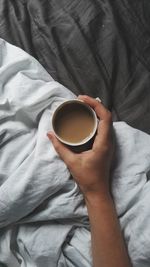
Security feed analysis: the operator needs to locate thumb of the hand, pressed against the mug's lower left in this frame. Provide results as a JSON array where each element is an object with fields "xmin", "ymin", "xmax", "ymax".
[{"xmin": 47, "ymin": 132, "xmax": 75, "ymax": 167}]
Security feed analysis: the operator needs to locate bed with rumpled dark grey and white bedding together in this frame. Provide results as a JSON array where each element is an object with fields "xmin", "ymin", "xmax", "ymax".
[{"xmin": 0, "ymin": 0, "xmax": 150, "ymax": 267}]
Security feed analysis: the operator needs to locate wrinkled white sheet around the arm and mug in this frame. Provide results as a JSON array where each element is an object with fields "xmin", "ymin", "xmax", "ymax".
[{"xmin": 0, "ymin": 39, "xmax": 150, "ymax": 267}]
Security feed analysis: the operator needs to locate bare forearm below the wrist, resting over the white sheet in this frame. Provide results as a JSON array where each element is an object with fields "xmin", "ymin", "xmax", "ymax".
[{"xmin": 85, "ymin": 195, "xmax": 131, "ymax": 267}]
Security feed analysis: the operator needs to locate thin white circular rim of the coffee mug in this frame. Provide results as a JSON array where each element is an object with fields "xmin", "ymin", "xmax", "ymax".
[{"xmin": 52, "ymin": 99, "xmax": 98, "ymax": 147}]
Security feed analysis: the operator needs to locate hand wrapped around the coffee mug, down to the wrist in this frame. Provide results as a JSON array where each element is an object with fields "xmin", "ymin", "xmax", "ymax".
[{"xmin": 47, "ymin": 95, "xmax": 113, "ymax": 201}]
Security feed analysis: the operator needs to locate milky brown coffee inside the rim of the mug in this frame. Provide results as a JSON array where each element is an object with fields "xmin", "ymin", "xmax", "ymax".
[{"xmin": 54, "ymin": 103, "xmax": 94, "ymax": 143}]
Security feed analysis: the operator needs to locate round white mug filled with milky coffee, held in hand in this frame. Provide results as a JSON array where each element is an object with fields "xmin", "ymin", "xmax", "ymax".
[{"xmin": 52, "ymin": 99, "xmax": 97, "ymax": 152}]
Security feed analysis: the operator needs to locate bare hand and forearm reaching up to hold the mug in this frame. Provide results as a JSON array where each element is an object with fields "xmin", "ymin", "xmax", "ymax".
[{"xmin": 48, "ymin": 96, "xmax": 131, "ymax": 267}]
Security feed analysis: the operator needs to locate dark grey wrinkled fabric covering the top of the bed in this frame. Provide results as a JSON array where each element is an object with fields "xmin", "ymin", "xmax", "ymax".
[{"xmin": 0, "ymin": 0, "xmax": 150, "ymax": 133}]
